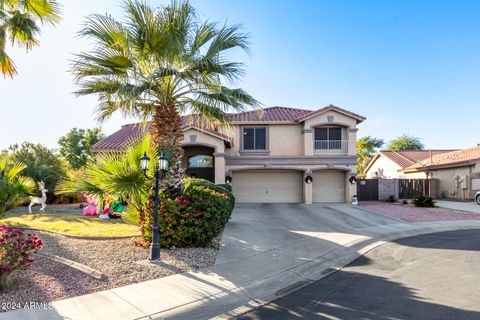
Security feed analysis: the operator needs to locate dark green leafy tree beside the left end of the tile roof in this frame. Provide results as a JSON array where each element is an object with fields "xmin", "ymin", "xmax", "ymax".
[{"xmin": 58, "ymin": 128, "xmax": 105, "ymax": 169}]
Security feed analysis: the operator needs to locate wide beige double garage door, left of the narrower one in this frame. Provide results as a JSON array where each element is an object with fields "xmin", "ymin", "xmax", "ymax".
[{"xmin": 232, "ymin": 170, "xmax": 303, "ymax": 203}]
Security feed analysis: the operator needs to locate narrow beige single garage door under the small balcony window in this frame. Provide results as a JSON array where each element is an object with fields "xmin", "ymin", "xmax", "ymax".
[{"xmin": 312, "ymin": 170, "xmax": 345, "ymax": 202}]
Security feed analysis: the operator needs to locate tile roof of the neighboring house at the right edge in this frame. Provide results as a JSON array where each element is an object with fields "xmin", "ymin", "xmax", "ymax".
[{"xmin": 405, "ymin": 146, "xmax": 480, "ymax": 171}]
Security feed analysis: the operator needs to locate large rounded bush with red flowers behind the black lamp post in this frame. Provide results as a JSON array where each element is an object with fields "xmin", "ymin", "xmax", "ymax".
[{"xmin": 142, "ymin": 185, "xmax": 231, "ymax": 247}]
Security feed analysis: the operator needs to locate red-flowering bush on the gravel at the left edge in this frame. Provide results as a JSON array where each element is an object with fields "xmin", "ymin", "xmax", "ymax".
[{"xmin": 0, "ymin": 226, "xmax": 42, "ymax": 289}]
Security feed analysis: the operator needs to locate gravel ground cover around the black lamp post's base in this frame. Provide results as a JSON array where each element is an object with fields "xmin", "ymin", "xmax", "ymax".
[{"xmin": 0, "ymin": 232, "xmax": 217, "ymax": 312}]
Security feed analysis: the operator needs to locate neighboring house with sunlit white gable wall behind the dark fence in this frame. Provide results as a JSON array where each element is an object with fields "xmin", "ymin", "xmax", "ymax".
[{"xmin": 365, "ymin": 150, "xmax": 454, "ymax": 179}]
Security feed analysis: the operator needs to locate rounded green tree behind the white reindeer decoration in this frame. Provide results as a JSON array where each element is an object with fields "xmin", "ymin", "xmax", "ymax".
[{"xmin": 9, "ymin": 142, "xmax": 66, "ymax": 202}]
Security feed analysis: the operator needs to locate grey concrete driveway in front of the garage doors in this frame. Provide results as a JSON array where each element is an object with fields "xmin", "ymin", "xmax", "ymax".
[{"xmin": 216, "ymin": 203, "xmax": 404, "ymax": 264}]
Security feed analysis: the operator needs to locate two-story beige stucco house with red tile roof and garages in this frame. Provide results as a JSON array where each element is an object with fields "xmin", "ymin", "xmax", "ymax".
[{"xmin": 92, "ymin": 105, "xmax": 365, "ymax": 203}]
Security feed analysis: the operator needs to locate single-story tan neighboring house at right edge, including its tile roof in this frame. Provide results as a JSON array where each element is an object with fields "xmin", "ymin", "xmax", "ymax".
[{"xmin": 403, "ymin": 146, "xmax": 480, "ymax": 199}]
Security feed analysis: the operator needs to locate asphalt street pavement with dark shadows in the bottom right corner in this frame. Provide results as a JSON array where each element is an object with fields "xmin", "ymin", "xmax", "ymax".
[{"xmin": 238, "ymin": 230, "xmax": 480, "ymax": 320}]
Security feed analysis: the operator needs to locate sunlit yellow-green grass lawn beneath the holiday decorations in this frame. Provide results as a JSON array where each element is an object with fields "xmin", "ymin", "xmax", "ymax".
[{"xmin": 0, "ymin": 211, "xmax": 140, "ymax": 237}]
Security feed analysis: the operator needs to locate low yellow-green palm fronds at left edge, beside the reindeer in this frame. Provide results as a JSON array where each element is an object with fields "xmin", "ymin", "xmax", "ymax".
[{"xmin": 0, "ymin": 154, "xmax": 35, "ymax": 217}]
